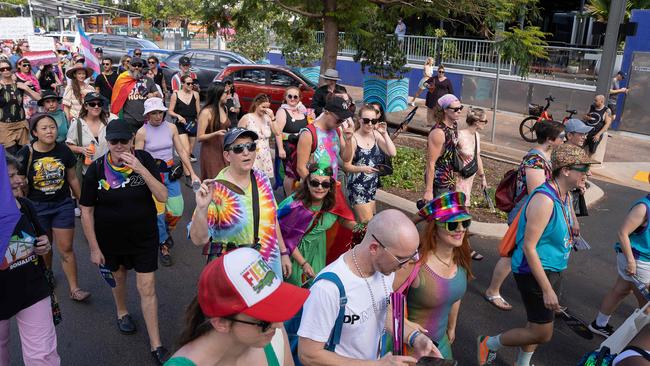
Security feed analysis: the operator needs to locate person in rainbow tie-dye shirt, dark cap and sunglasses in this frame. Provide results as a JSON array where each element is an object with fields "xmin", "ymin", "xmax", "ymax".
[{"xmin": 189, "ymin": 127, "xmax": 291, "ymax": 277}]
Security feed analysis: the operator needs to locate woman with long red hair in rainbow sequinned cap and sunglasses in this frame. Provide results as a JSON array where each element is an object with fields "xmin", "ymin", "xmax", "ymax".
[{"xmin": 394, "ymin": 192, "xmax": 472, "ymax": 359}]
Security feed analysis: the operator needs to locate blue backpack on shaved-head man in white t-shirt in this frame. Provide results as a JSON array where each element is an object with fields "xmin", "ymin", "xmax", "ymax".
[{"xmin": 284, "ymin": 272, "xmax": 348, "ymax": 366}]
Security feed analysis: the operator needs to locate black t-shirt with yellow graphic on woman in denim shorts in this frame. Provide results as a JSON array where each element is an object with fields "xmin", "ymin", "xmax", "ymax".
[{"xmin": 17, "ymin": 142, "xmax": 77, "ymax": 202}]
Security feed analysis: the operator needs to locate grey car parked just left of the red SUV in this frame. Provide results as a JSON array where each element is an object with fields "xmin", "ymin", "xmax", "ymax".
[{"xmin": 160, "ymin": 48, "xmax": 254, "ymax": 91}]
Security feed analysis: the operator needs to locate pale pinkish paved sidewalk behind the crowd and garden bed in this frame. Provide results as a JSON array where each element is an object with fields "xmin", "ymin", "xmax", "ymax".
[{"xmin": 346, "ymin": 86, "xmax": 650, "ymax": 191}]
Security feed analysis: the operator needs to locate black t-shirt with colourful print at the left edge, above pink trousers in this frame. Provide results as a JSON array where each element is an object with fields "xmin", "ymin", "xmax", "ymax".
[{"xmin": 0, "ymin": 198, "xmax": 50, "ymax": 320}]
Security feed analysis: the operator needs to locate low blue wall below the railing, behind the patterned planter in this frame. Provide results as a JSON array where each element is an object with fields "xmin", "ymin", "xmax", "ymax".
[{"xmin": 268, "ymin": 52, "xmax": 463, "ymax": 100}]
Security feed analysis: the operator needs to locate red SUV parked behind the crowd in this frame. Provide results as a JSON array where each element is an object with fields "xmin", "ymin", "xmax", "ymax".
[{"xmin": 214, "ymin": 64, "xmax": 318, "ymax": 113}]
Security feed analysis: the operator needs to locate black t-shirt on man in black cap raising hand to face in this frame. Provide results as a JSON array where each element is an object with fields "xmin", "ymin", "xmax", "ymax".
[{"xmin": 79, "ymin": 150, "xmax": 162, "ymax": 255}]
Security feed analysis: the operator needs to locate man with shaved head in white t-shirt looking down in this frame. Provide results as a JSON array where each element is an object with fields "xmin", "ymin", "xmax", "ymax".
[{"xmin": 298, "ymin": 210, "xmax": 440, "ymax": 365}]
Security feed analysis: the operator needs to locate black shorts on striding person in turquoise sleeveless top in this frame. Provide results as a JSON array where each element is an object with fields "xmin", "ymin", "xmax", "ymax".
[{"xmin": 513, "ymin": 271, "xmax": 562, "ymax": 324}]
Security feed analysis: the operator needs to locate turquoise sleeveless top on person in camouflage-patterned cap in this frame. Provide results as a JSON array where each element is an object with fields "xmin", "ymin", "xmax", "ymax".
[{"xmin": 512, "ymin": 181, "xmax": 573, "ymax": 274}]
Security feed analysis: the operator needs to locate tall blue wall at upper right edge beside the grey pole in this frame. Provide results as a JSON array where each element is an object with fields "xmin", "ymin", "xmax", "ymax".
[{"xmin": 613, "ymin": 9, "xmax": 650, "ymax": 128}]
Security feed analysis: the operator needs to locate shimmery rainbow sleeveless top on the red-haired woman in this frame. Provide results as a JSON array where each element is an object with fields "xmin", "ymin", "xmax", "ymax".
[{"xmin": 406, "ymin": 264, "xmax": 467, "ymax": 359}]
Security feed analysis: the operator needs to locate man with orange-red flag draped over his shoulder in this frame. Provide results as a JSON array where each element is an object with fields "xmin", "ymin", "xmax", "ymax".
[{"xmin": 111, "ymin": 57, "xmax": 162, "ymax": 130}]
